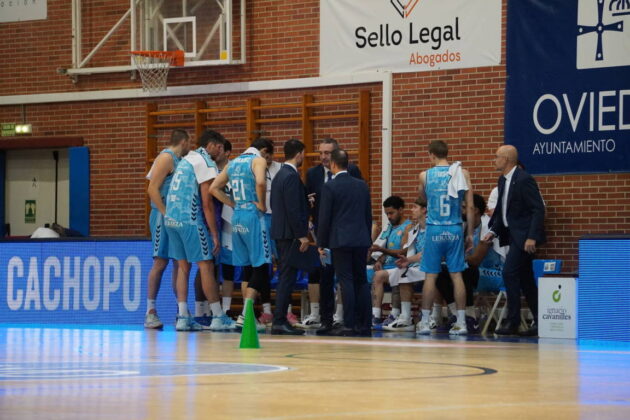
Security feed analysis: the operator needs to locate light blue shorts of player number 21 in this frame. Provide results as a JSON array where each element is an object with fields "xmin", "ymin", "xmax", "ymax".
[{"xmin": 232, "ymin": 208, "xmax": 271, "ymax": 267}]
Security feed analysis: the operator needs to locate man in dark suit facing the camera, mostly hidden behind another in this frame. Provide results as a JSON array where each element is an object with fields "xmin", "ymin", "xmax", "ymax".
[{"xmin": 306, "ymin": 138, "xmax": 363, "ymax": 334}]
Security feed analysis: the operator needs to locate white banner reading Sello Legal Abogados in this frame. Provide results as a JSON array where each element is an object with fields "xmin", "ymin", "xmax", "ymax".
[{"xmin": 320, "ymin": 0, "xmax": 501, "ymax": 75}]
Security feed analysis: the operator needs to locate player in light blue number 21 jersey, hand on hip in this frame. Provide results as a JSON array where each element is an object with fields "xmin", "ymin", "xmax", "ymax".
[{"xmin": 210, "ymin": 138, "xmax": 273, "ymax": 332}]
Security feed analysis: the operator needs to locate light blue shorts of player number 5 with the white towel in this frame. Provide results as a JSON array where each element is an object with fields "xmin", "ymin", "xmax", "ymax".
[{"xmin": 165, "ymin": 220, "xmax": 214, "ymax": 263}]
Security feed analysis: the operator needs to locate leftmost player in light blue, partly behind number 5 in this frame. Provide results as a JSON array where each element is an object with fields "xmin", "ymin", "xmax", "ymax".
[{"xmin": 144, "ymin": 129, "xmax": 190, "ymax": 328}]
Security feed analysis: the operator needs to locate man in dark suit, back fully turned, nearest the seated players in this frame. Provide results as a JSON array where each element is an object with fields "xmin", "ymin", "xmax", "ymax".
[{"xmin": 317, "ymin": 149, "xmax": 372, "ymax": 336}]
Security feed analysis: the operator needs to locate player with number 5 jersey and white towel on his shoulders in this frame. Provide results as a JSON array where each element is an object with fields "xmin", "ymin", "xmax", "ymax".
[{"xmin": 164, "ymin": 141, "xmax": 234, "ymax": 331}]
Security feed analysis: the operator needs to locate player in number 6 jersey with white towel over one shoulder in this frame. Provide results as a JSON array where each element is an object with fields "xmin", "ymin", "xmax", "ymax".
[{"xmin": 417, "ymin": 140, "xmax": 474, "ymax": 335}]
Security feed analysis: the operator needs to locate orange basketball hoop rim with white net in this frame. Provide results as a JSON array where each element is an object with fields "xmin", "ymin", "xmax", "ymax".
[{"xmin": 131, "ymin": 51, "xmax": 184, "ymax": 92}]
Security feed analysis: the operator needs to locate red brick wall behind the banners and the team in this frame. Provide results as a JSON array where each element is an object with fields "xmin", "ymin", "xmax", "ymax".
[{"xmin": 0, "ymin": 0, "xmax": 630, "ymax": 270}]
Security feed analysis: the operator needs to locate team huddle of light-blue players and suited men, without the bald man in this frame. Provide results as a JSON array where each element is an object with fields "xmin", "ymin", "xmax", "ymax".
[{"xmin": 145, "ymin": 130, "xmax": 524, "ymax": 335}]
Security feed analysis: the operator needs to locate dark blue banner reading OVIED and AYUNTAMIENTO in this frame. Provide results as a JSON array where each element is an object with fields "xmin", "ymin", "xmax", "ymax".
[{"xmin": 505, "ymin": 0, "xmax": 630, "ymax": 174}]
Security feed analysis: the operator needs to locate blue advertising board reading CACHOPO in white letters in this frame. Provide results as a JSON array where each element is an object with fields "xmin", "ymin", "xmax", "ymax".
[{"xmin": 0, "ymin": 240, "xmax": 177, "ymax": 325}]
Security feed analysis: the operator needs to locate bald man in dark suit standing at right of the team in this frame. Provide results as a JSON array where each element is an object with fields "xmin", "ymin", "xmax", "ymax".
[{"xmin": 484, "ymin": 145, "xmax": 546, "ymax": 335}]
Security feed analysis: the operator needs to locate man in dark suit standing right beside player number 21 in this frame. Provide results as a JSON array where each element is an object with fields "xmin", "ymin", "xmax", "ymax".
[{"xmin": 271, "ymin": 139, "xmax": 308, "ymax": 335}]
